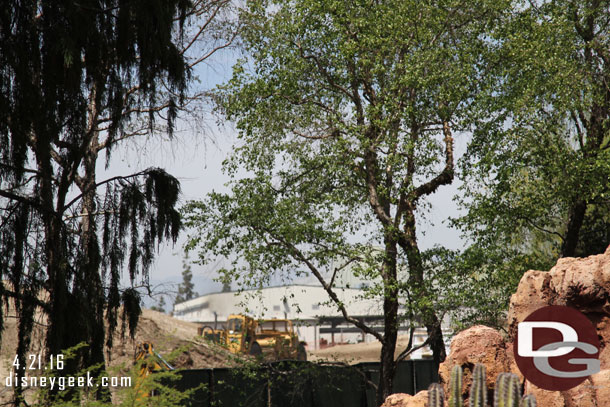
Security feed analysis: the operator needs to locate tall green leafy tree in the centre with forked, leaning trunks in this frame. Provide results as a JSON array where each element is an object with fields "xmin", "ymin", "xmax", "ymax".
[{"xmin": 185, "ymin": 0, "xmax": 502, "ymax": 404}]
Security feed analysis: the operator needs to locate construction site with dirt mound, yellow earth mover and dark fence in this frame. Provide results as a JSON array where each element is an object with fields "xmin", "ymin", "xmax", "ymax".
[{"xmin": 0, "ymin": 309, "xmax": 437, "ymax": 407}]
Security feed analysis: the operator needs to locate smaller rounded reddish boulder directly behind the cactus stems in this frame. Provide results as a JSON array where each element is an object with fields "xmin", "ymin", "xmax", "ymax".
[{"xmin": 439, "ymin": 325, "xmax": 518, "ymax": 397}]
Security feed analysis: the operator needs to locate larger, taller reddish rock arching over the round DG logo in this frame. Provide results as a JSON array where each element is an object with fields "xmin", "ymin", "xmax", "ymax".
[{"xmin": 508, "ymin": 247, "xmax": 610, "ymax": 369}]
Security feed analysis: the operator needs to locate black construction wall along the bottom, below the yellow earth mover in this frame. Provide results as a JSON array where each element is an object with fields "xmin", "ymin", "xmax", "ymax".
[{"xmin": 172, "ymin": 360, "xmax": 438, "ymax": 407}]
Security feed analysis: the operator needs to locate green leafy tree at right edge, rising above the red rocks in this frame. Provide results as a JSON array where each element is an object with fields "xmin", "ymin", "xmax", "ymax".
[{"xmin": 459, "ymin": 0, "xmax": 610, "ymax": 316}]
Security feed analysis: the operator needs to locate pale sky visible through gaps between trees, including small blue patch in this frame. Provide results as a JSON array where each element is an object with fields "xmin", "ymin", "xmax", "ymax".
[{"xmin": 98, "ymin": 42, "xmax": 467, "ymax": 310}]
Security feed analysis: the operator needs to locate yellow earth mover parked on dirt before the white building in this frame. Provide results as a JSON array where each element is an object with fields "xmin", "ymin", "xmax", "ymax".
[{"xmin": 200, "ymin": 315, "xmax": 307, "ymax": 360}]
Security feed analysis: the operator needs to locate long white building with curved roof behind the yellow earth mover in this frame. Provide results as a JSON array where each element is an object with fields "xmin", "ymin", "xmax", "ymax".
[{"xmin": 173, "ymin": 285, "xmax": 446, "ymax": 358}]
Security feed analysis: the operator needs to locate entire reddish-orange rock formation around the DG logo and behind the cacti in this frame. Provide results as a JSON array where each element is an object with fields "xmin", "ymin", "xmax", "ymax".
[{"xmin": 384, "ymin": 247, "xmax": 610, "ymax": 407}]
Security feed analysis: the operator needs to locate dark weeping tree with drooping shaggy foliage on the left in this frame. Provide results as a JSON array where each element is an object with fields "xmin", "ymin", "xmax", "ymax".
[{"xmin": 0, "ymin": 0, "xmax": 233, "ymax": 402}]
